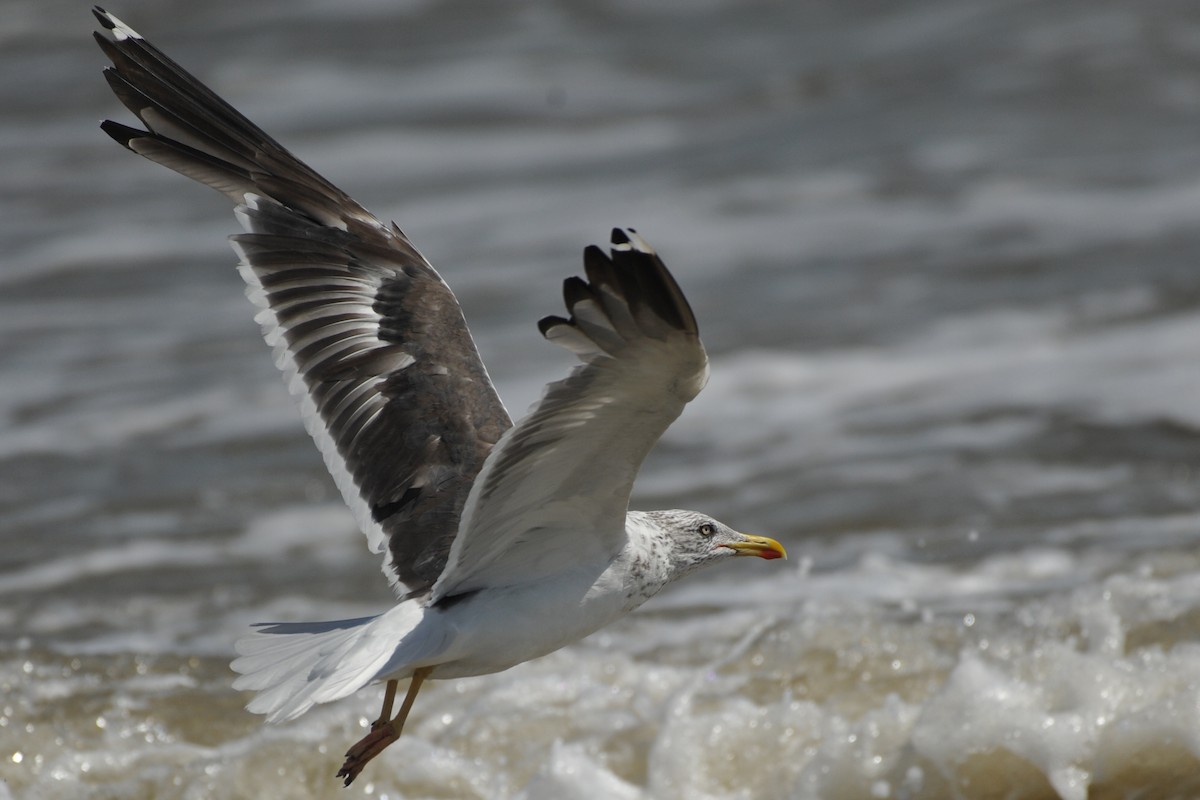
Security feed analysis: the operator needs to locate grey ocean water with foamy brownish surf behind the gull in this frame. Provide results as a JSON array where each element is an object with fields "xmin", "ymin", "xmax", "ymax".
[{"xmin": 7, "ymin": 0, "xmax": 1200, "ymax": 800}]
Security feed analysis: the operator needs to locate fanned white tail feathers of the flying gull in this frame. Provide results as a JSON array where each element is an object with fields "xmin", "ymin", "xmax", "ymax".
[{"xmin": 230, "ymin": 603, "xmax": 421, "ymax": 722}]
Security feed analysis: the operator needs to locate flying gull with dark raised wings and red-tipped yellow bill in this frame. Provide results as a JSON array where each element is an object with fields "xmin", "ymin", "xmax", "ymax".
[{"xmin": 94, "ymin": 7, "xmax": 787, "ymax": 786}]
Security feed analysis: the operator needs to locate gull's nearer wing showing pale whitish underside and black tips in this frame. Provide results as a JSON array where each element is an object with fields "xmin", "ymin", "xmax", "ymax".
[{"xmin": 432, "ymin": 229, "xmax": 708, "ymax": 602}]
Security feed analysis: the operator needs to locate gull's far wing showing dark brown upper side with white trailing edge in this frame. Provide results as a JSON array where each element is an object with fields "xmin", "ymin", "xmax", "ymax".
[{"xmin": 95, "ymin": 8, "xmax": 511, "ymax": 593}]
